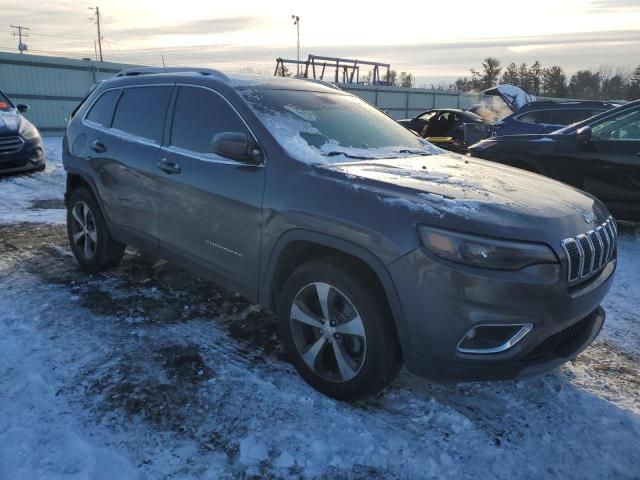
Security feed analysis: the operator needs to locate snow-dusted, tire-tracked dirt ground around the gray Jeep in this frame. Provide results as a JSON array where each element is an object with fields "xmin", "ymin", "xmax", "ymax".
[{"xmin": 0, "ymin": 139, "xmax": 640, "ymax": 480}]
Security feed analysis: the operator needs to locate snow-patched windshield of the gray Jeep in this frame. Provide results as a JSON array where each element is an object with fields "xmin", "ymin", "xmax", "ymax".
[{"xmin": 241, "ymin": 88, "xmax": 442, "ymax": 163}]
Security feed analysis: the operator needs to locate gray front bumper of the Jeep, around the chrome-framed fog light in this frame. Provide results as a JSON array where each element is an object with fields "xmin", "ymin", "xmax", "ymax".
[{"xmin": 389, "ymin": 248, "xmax": 616, "ymax": 382}]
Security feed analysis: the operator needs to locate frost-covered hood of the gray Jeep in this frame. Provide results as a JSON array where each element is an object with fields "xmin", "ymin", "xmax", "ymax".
[{"xmin": 320, "ymin": 154, "xmax": 608, "ymax": 242}]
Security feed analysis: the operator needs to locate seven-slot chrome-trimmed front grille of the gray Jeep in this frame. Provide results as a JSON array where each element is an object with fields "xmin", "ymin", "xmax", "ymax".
[{"xmin": 562, "ymin": 217, "xmax": 618, "ymax": 282}]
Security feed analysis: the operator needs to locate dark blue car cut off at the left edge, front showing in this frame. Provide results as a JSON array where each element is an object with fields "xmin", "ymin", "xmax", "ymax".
[{"xmin": 0, "ymin": 91, "xmax": 45, "ymax": 175}]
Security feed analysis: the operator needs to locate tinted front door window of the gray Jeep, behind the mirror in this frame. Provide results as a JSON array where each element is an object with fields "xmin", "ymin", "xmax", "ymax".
[{"xmin": 171, "ymin": 87, "xmax": 249, "ymax": 154}]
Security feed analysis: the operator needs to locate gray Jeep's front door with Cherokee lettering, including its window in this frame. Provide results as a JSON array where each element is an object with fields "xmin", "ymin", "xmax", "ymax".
[{"xmin": 156, "ymin": 85, "xmax": 265, "ymax": 289}]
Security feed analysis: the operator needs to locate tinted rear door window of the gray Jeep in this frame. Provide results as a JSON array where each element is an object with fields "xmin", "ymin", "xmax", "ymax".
[{"xmin": 113, "ymin": 86, "xmax": 171, "ymax": 144}]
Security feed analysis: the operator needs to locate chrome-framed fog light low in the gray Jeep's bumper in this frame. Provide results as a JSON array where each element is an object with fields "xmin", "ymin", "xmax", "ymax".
[{"xmin": 458, "ymin": 323, "xmax": 533, "ymax": 354}]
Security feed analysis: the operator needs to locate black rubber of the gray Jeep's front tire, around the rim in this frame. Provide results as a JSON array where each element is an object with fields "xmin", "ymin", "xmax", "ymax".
[{"xmin": 278, "ymin": 257, "xmax": 402, "ymax": 400}]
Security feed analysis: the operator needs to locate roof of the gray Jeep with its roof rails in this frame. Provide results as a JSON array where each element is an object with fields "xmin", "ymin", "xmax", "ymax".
[{"xmin": 104, "ymin": 67, "xmax": 342, "ymax": 93}]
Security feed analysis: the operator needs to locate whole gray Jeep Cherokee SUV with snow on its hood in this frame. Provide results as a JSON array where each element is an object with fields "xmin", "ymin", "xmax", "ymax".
[{"xmin": 63, "ymin": 69, "xmax": 617, "ymax": 400}]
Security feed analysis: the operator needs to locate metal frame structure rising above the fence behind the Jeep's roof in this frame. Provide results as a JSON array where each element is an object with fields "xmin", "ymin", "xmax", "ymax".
[{"xmin": 273, "ymin": 54, "xmax": 391, "ymax": 85}]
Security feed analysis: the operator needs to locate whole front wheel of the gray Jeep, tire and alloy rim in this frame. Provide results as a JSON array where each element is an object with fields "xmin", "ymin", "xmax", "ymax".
[{"xmin": 278, "ymin": 258, "xmax": 402, "ymax": 400}]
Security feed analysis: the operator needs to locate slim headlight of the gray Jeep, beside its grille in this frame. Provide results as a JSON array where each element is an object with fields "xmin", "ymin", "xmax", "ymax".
[{"xmin": 418, "ymin": 226, "xmax": 558, "ymax": 270}]
